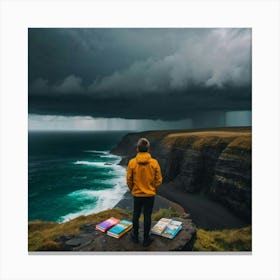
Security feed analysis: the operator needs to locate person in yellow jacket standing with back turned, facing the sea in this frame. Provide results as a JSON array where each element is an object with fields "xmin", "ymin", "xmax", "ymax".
[{"xmin": 126, "ymin": 138, "xmax": 162, "ymax": 247}]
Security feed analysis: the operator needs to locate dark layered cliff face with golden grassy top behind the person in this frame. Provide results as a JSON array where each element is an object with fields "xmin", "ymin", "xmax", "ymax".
[{"xmin": 112, "ymin": 128, "xmax": 251, "ymax": 221}]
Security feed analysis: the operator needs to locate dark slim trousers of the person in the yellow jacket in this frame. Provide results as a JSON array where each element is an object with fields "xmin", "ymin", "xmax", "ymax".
[{"xmin": 132, "ymin": 196, "xmax": 155, "ymax": 239}]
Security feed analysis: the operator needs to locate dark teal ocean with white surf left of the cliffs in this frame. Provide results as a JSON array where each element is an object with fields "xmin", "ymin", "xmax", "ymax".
[{"xmin": 28, "ymin": 131, "xmax": 127, "ymax": 223}]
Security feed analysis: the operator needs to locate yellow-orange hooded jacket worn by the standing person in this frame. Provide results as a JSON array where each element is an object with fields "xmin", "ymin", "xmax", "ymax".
[{"xmin": 126, "ymin": 152, "xmax": 162, "ymax": 196}]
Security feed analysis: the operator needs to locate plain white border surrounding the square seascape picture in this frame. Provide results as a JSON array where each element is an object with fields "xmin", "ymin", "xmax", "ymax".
[{"xmin": 0, "ymin": 0, "xmax": 280, "ymax": 279}]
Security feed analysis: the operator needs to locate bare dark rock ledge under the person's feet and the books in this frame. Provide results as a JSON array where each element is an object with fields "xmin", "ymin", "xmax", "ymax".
[{"xmin": 49, "ymin": 218, "xmax": 196, "ymax": 252}]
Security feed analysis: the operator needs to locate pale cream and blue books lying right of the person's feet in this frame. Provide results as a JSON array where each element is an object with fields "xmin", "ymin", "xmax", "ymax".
[{"xmin": 151, "ymin": 218, "xmax": 182, "ymax": 239}]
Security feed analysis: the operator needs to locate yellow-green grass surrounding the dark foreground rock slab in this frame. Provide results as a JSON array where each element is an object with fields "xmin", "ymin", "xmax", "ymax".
[{"xmin": 28, "ymin": 208, "xmax": 252, "ymax": 251}]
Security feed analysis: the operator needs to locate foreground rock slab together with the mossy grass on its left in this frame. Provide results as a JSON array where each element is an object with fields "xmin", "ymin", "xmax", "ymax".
[{"xmin": 28, "ymin": 208, "xmax": 197, "ymax": 252}]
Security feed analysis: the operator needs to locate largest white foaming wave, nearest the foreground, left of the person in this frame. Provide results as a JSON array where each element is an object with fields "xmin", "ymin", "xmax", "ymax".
[{"xmin": 58, "ymin": 178, "xmax": 127, "ymax": 223}]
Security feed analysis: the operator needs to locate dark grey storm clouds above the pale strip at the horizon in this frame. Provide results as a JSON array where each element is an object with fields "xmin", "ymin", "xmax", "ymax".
[{"xmin": 28, "ymin": 28, "xmax": 252, "ymax": 126}]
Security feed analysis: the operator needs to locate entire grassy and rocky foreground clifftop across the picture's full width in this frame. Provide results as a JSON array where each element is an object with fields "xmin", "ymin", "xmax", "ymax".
[{"xmin": 28, "ymin": 208, "xmax": 252, "ymax": 253}]
